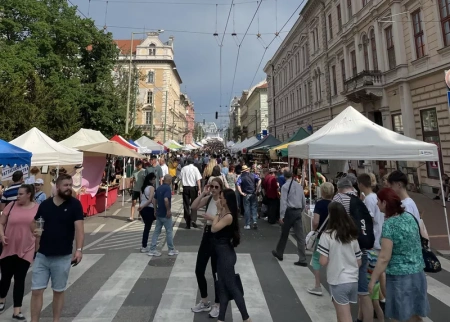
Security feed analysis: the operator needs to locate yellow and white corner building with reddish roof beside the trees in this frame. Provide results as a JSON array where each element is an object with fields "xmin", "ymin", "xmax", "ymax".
[{"xmin": 115, "ymin": 32, "xmax": 195, "ymax": 143}]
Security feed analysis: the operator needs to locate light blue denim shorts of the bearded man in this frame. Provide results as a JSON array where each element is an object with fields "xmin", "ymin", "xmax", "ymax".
[{"xmin": 31, "ymin": 253, "xmax": 72, "ymax": 292}]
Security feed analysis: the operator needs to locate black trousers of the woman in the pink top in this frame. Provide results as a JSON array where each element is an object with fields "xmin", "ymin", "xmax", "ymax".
[{"xmin": 0, "ymin": 255, "xmax": 30, "ymax": 307}]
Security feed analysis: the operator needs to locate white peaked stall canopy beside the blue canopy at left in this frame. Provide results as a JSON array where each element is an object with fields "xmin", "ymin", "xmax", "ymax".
[{"xmin": 9, "ymin": 127, "xmax": 83, "ymax": 167}]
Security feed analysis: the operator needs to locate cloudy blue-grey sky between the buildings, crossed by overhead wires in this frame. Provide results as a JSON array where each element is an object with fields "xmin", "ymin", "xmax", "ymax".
[{"xmin": 70, "ymin": 0, "xmax": 303, "ymax": 126}]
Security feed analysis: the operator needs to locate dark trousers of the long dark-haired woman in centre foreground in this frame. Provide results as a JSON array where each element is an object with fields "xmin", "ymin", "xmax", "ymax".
[{"xmin": 215, "ymin": 240, "xmax": 249, "ymax": 321}]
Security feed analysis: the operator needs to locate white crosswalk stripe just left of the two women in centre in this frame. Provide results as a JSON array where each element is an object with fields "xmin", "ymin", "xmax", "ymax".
[{"xmin": 153, "ymin": 253, "xmax": 198, "ymax": 322}]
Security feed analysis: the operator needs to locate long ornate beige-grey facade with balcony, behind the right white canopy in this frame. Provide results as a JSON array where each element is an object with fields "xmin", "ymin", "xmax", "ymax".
[{"xmin": 264, "ymin": 0, "xmax": 450, "ymax": 186}]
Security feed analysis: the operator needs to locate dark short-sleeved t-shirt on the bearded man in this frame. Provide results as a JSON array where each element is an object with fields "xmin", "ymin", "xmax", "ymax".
[{"xmin": 34, "ymin": 197, "xmax": 84, "ymax": 256}]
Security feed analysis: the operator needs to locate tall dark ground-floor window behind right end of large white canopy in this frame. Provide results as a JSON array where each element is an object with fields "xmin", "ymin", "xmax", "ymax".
[{"xmin": 420, "ymin": 108, "xmax": 442, "ymax": 179}]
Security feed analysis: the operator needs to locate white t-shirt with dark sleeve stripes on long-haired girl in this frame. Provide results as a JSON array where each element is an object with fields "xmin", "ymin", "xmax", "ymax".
[{"xmin": 317, "ymin": 232, "xmax": 361, "ymax": 285}]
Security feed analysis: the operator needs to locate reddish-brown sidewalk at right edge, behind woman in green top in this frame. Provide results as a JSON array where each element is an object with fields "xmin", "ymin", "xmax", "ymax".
[{"xmin": 408, "ymin": 192, "xmax": 450, "ymax": 255}]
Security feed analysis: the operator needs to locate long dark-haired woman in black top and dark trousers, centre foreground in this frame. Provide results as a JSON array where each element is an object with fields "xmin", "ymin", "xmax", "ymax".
[{"xmin": 211, "ymin": 189, "xmax": 251, "ymax": 322}]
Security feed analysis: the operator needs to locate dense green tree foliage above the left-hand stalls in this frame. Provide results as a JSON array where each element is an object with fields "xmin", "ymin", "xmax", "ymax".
[{"xmin": 0, "ymin": 0, "xmax": 134, "ymax": 141}]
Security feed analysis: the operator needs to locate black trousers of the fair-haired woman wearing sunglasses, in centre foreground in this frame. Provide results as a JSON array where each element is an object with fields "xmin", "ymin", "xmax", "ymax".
[{"xmin": 195, "ymin": 225, "xmax": 219, "ymax": 303}]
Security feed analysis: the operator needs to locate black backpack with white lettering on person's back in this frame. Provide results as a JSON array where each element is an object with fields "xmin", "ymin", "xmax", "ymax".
[{"xmin": 347, "ymin": 194, "xmax": 375, "ymax": 250}]
